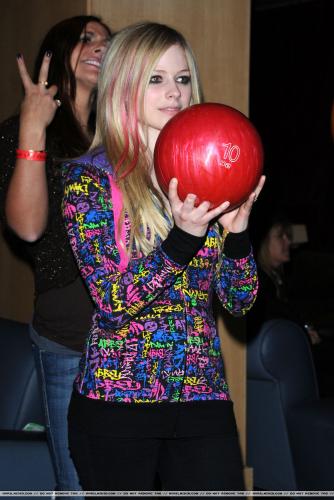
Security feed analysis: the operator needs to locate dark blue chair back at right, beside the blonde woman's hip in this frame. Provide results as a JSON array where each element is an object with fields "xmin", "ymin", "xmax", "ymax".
[{"xmin": 247, "ymin": 319, "xmax": 319, "ymax": 490}]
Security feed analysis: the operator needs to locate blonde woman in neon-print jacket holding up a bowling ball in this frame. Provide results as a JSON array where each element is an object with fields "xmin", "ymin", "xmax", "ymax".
[{"xmin": 63, "ymin": 23, "xmax": 264, "ymax": 491}]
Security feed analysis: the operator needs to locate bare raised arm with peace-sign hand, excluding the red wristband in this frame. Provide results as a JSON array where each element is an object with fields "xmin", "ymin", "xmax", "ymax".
[{"xmin": 6, "ymin": 54, "xmax": 60, "ymax": 242}]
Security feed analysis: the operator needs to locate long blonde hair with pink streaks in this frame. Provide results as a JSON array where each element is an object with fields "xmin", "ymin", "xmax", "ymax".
[{"xmin": 91, "ymin": 23, "xmax": 201, "ymax": 255}]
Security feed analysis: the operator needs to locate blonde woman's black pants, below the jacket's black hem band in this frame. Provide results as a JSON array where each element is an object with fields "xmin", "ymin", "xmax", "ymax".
[{"xmin": 70, "ymin": 428, "xmax": 244, "ymax": 491}]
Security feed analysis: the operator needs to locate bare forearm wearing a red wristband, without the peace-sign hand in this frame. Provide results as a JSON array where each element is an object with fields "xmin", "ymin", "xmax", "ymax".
[{"xmin": 5, "ymin": 124, "xmax": 48, "ymax": 241}]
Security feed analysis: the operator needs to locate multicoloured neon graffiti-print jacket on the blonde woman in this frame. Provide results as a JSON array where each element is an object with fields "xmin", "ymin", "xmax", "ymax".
[{"xmin": 63, "ymin": 148, "xmax": 257, "ymax": 403}]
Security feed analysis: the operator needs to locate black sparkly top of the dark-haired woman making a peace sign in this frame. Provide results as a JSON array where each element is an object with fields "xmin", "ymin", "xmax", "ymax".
[{"xmin": 0, "ymin": 116, "xmax": 93, "ymax": 350}]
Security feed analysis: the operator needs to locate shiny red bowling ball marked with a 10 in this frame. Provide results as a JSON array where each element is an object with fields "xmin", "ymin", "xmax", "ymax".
[{"xmin": 154, "ymin": 103, "xmax": 263, "ymax": 209}]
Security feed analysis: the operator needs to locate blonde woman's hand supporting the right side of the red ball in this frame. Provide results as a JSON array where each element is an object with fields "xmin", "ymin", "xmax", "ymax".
[{"xmin": 218, "ymin": 175, "xmax": 266, "ymax": 233}]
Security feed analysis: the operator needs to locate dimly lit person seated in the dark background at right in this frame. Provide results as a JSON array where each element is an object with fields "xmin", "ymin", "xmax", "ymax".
[{"xmin": 248, "ymin": 217, "xmax": 334, "ymax": 397}]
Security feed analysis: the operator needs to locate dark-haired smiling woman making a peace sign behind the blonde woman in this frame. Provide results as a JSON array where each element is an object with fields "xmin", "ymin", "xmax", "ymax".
[{"xmin": 0, "ymin": 16, "xmax": 111, "ymax": 491}]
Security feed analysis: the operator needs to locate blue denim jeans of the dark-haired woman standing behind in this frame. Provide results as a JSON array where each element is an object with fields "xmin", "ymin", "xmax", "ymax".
[{"xmin": 33, "ymin": 343, "xmax": 81, "ymax": 499}]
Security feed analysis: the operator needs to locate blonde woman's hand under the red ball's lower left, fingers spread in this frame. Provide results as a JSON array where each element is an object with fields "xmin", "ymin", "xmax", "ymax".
[{"xmin": 168, "ymin": 178, "xmax": 230, "ymax": 236}]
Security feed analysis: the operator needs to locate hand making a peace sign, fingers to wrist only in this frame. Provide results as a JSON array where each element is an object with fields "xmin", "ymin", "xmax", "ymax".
[{"xmin": 17, "ymin": 53, "xmax": 61, "ymax": 132}]
